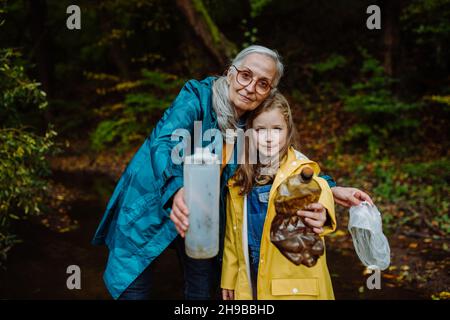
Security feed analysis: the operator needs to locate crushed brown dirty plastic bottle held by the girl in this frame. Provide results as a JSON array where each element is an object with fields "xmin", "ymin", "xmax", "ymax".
[{"xmin": 270, "ymin": 167, "xmax": 324, "ymax": 267}]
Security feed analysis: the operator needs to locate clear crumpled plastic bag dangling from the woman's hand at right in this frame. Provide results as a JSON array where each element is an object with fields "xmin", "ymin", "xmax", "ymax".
[{"xmin": 348, "ymin": 201, "xmax": 391, "ymax": 270}]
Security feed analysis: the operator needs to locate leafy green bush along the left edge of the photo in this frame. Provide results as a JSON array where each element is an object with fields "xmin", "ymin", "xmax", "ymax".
[{"xmin": 0, "ymin": 49, "xmax": 56, "ymax": 265}]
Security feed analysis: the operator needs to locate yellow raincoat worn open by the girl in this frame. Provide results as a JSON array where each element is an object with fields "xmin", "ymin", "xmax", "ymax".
[{"xmin": 221, "ymin": 148, "xmax": 336, "ymax": 300}]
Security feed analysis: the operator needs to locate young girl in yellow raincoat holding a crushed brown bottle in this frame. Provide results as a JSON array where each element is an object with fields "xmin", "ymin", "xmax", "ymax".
[{"xmin": 221, "ymin": 93, "xmax": 336, "ymax": 300}]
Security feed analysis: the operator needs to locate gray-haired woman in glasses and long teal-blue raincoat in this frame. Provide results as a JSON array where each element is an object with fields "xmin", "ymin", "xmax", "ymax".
[{"xmin": 93, "ymin": 46, "xmax": 372, "ymax": 299}]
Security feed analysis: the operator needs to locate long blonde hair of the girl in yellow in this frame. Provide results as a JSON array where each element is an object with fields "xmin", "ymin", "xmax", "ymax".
[{"xmin": 234, "ymin": 91, "xmax": 296, "ymax": 195}]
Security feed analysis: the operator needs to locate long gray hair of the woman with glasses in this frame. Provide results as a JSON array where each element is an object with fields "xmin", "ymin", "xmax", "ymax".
[{"xmin": 212, "ymin": 45, "xmax": 284, "ymax": 134}]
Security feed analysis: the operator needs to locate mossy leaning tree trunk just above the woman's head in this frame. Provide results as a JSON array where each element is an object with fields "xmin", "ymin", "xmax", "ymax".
[{"xmin": 176, "ymin": 0, "xmax": 237, "ymax": 66}]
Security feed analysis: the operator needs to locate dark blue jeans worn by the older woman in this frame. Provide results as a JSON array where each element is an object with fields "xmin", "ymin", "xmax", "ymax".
[{"xmin": 119, "ymin": 236, "xmax": 221, "ymax": 300}]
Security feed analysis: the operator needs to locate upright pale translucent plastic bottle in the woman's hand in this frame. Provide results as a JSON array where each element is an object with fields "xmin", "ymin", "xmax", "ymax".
[{"xmin": 183, "ymin": 148, "xmax": 220, "ymax": 259}]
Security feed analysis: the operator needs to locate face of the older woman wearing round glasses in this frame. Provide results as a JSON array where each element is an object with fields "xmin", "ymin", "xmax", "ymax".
[{"xmin": 227, "ymin": 53, "xmax": 277, "ymax": 117}]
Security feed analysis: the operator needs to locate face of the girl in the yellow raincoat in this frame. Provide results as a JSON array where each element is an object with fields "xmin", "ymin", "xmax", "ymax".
[{"xmin": 252, "ymin": 108, "xmax": 288, "ymax": 157}]
